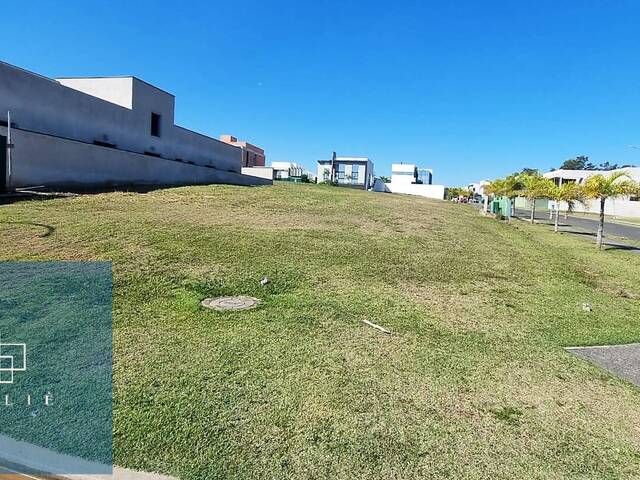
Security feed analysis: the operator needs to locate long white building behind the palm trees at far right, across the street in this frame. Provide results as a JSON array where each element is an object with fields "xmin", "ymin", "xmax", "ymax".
[{"xmin": 544, "ymin": 167, "xmax": 640, "ymax": 217}]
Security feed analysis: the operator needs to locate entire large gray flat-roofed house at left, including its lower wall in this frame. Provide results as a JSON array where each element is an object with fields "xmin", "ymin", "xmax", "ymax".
[{"xmin": 0, "ymin": 62, "xmax": 271, "ymax": 190}]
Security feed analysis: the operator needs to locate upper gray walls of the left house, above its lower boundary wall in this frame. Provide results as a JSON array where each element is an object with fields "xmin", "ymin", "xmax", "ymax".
[{"xmin": 0, "ymin": 62, "xmax": 242, "ymax": 173}]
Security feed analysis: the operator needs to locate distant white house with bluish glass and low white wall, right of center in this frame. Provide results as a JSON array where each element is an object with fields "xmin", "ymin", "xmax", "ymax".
[{"xmin": 374, "ymin": 163, "xmax": 445, "ymax": 200}]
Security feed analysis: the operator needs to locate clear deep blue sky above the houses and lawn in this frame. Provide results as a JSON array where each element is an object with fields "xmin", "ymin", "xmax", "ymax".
[{"xmin": 5, "ymin": 0, "xmax": 640, "ymax": 186}]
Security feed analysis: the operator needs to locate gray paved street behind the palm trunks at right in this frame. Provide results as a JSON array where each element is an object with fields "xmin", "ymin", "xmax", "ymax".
[{"xmin": 516, "ymin": 209, "xmax": 640, "ymax": 251}]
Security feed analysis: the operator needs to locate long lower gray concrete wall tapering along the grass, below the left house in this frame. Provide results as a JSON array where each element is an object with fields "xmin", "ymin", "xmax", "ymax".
[{"xmin": 0, "ymin": 127, "xmax": 273, "ymax": 188}]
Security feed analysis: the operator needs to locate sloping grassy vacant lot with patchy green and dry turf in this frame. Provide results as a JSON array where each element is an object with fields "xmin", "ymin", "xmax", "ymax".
[{"xmin": 0, "ymin": 185, "xmax": 640, "ymax": 479}]
